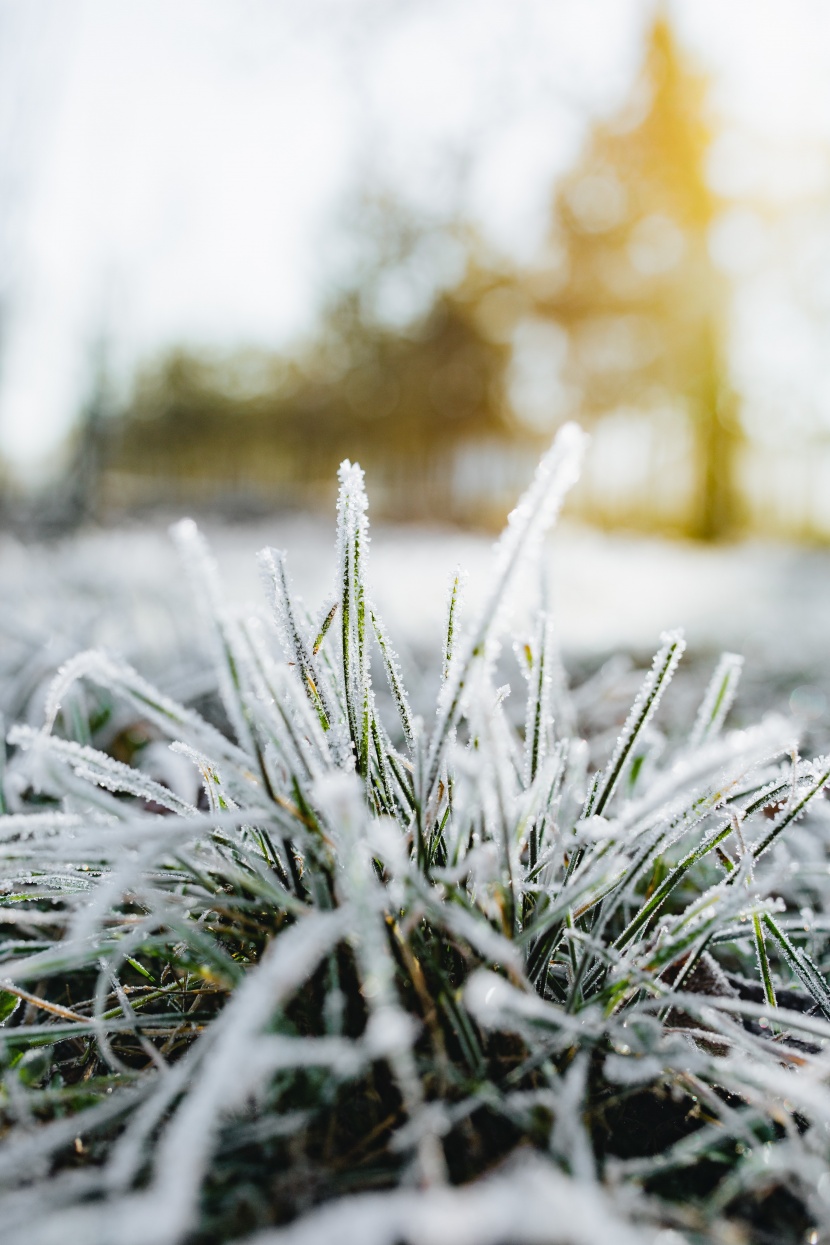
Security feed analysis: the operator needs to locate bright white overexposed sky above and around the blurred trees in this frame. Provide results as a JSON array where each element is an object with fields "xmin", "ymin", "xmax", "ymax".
[{"xmin": 0, "ymin": 0, "xmax": 830, "ymax": 473}]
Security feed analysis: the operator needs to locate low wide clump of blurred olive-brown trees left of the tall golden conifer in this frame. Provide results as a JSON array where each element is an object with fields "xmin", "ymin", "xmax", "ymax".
[{"xmin": 103, "ymin": 270, "xmax": 509, "ymax": 519}]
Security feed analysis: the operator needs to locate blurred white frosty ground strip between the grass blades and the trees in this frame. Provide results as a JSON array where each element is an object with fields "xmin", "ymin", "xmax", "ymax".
[{"xmin": 0, "ymin": 515, "xmax": 830, "ymax": 730}]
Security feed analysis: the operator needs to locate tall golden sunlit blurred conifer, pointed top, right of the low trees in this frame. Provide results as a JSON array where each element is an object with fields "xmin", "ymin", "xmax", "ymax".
[{"xmin": 523, "ymin": 17, "xmax": 737, "ymax": 539}]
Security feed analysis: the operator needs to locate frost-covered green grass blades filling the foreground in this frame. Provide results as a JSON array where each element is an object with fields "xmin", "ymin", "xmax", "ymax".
[{"xmin": 0, "ymin": 427, "xmax": 830, "ymax": 1245}]
